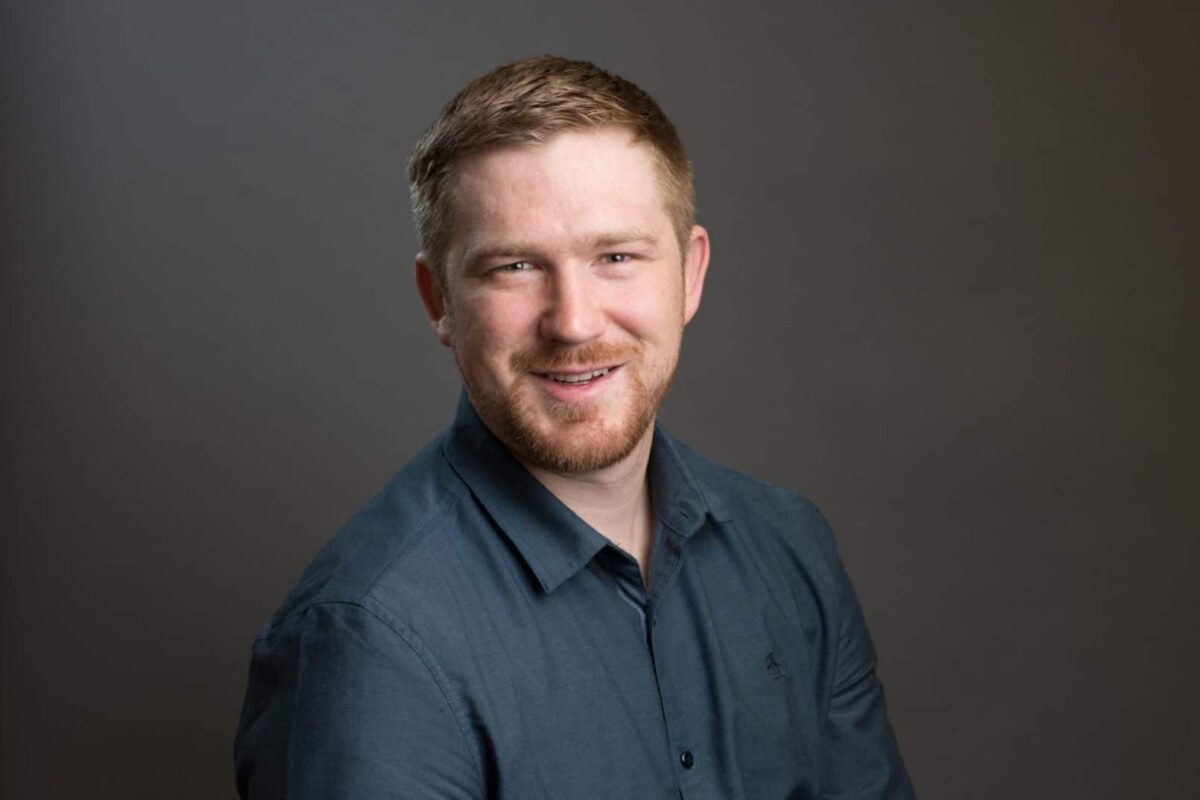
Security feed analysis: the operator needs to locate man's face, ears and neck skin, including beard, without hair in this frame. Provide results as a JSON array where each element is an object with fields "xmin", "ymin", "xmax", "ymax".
[{"xmin": 416, "ymin": 127, "xmax": 709, "ymax": 573}]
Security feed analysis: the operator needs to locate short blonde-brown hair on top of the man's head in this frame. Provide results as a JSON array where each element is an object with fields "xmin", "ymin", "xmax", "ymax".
[{"xmin": 408, "ymin": 55, "xmax": 696, "ymax": 282}]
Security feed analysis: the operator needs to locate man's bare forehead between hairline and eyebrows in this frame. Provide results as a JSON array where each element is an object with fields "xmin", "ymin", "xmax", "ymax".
[{"xmin": 449, "ymin": 127, "xmax": 671, "ymax": 255}]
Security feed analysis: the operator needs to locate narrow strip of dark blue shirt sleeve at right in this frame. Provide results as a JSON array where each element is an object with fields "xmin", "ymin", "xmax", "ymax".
[{"xmin": 817, "ymin": 513, "xmax": 916, "ymax": 800}]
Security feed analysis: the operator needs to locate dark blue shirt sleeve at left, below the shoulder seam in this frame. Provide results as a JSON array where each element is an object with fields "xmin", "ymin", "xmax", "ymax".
[{"xmin": 234, "ymin": 603, "xmax": 484, "ymax": 800}]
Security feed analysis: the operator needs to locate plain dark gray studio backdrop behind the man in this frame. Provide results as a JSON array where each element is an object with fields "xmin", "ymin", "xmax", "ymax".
[{"xmin": 0, "ymin": 0, "xmax": 1200, "ymax": 800}]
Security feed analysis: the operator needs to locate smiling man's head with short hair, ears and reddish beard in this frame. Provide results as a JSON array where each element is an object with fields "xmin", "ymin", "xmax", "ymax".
[{"xmin": 410, "ymin": 58, "xmax": 708, "ymax": 474}]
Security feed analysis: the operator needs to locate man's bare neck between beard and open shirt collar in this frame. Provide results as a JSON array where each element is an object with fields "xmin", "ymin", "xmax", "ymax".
[{"xmin": 522, "ymin": 423, "xmax": 654, "ymax": 584}]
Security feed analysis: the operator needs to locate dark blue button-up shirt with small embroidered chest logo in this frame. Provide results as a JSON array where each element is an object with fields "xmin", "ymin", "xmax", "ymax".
[{"xmin": 235, "ymin": 399, "xmax": 913, "ymax": 800}]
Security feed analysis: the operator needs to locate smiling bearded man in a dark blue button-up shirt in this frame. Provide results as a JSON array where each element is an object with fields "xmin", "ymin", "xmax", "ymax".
[{"xmin": 236, "ymin": 58, "xmax": 912, "ymax": 800}]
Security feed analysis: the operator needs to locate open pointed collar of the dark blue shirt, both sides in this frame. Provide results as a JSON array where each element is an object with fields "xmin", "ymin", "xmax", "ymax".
[{"xmin": 443, "ymin": 391, "xmax": 708, "ymax": 593}]
